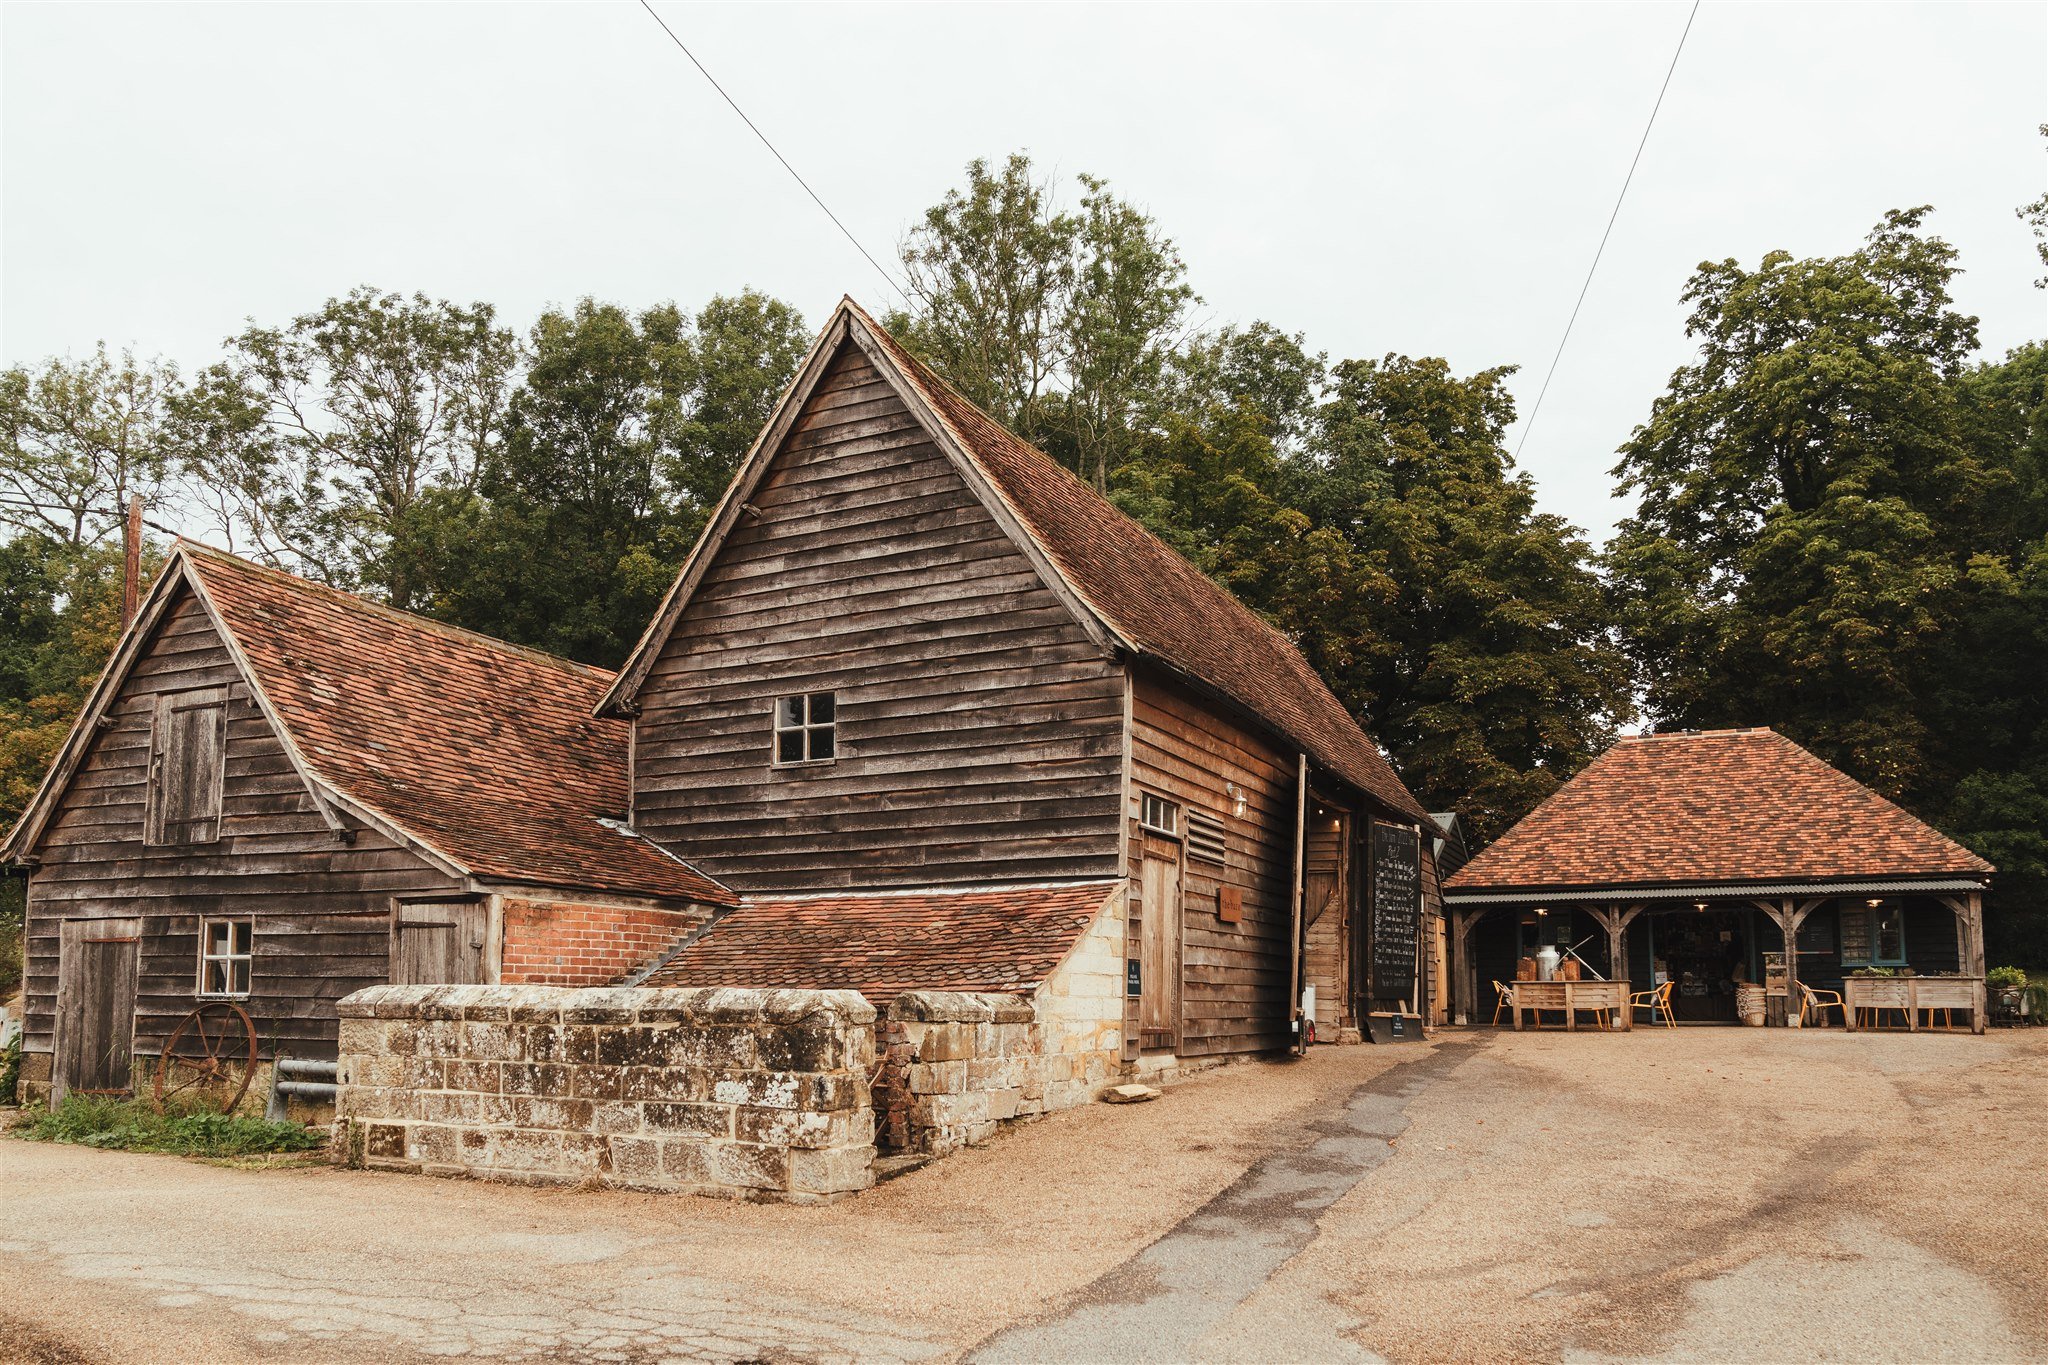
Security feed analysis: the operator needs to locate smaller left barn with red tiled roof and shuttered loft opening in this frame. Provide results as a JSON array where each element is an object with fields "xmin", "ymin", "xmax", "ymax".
[{"xmin": 0, "ymin": 542, "xmax": 735, "ymax": 1095}]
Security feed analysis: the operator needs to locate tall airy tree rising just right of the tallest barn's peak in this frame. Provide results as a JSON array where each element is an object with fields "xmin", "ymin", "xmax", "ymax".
[{"xmin": 891, "ymin": 153, "xmax": 1198, "ymax": 487}]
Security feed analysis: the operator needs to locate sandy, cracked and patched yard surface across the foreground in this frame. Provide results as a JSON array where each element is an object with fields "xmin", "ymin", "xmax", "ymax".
[{"xmin": 0, "ymin": 1029, "xmax": 2048, "ymax": 1365}]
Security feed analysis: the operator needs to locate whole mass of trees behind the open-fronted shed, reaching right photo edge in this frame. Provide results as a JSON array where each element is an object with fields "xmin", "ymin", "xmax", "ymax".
[{"xmin": 1608, "ymin": 209, "xmax": 2048, "ymax": 956}]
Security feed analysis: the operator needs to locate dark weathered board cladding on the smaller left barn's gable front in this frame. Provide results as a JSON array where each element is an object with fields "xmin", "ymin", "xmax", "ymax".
[{"xmin": 25, "ymin": 589, "xmax": 455, "ymax": 1056}]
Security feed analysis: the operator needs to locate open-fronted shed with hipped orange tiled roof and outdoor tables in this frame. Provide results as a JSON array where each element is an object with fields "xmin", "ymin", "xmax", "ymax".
[{"xmin": 1444, "ymin": 729, "xmax": 1993, "ymax": 1031}]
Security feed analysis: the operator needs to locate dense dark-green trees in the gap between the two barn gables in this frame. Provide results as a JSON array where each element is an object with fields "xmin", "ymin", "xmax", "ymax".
[{"xmin": 424, "ymin": 291, "xmax": 807, "ymax": 665}]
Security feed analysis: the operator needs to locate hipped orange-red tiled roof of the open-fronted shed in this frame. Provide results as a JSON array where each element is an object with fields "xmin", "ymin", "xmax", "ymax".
[{"xmin": 1446, "ymin": 729, "xmax": 1993, "ymax": 892}]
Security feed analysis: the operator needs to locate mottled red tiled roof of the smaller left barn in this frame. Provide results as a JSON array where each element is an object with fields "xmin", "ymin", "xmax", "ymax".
[{"xmin": 178, "ymin": 542, "xmax": 735, "ymax": 905}]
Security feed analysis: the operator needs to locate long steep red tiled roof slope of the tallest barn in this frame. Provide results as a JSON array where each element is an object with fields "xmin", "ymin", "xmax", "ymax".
[{"xmin": 848, "ymin": 303, "xmax": 1427, "ymax": 821}]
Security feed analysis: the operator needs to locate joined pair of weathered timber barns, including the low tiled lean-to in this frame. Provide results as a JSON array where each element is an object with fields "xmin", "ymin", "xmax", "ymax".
[{"xmin": 0, "ymin": 301, "xmax": 1444, "ymax": 1093}]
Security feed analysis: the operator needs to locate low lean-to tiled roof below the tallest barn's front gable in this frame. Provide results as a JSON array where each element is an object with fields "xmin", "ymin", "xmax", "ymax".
[{"xmin": 641, "ymin": 882, "xmax": 1118, "ymax": 1003}]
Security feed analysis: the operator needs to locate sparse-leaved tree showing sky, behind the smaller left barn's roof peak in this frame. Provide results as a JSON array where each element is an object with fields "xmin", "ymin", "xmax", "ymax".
[{"xmin": 180, "ymin": 287, "xmax": 518, "ymax": 608}]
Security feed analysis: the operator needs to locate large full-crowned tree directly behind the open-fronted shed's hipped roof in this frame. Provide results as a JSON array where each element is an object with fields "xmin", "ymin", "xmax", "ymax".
[{"xmin": 1608, "ymin": 209, "xmax": 1993, "ymax": 796}]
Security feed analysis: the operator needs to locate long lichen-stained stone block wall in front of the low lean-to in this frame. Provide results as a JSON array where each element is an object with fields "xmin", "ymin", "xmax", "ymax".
[{"xmin": 336, "ymin": 986, "xmax": 874, "ymax": 1203}]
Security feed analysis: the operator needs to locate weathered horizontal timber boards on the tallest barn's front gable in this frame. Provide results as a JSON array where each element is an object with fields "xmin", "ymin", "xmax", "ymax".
[{"xmin": 633, "ymin": 346, "xmax": 1122, "ymax": 890}]
